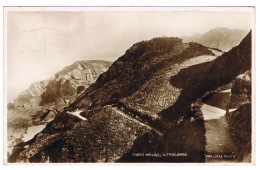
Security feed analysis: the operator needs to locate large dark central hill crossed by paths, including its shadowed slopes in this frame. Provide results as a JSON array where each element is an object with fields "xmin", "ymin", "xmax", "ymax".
[{"xmin": 9, "ymin": 33, "xmax": 251, "ymax": 162}]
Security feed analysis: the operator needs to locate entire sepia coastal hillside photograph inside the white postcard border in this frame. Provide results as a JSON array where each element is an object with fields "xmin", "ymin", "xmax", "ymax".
[{"xmin": 3, "ymin": 6, "xmax": 255, "ymax": 164}]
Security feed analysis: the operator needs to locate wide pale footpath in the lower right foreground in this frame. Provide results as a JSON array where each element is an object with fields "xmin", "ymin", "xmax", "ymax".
[{"xmin": 201, "ymin": 91, "xmax": 237, "ymax": 163}]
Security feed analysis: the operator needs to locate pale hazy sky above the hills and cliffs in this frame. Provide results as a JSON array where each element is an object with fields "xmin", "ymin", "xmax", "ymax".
[{"xmin": 4, "ymin": 8, "xmax": 253, "ymax": 101}]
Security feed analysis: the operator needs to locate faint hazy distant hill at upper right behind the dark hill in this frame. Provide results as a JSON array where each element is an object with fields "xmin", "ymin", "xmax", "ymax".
[{"xmin": 183, "ymin": 27, "xmax": 248, "ymax": 52}]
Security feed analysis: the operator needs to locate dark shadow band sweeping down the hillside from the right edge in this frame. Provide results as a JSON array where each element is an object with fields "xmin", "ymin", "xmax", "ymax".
[{"xmin": 160, "ymin": 31, "xmax": 251, "ymax": 121}]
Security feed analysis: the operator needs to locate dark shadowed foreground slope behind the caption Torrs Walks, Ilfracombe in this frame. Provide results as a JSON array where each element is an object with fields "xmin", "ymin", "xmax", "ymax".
[{"xmin": 117, "ymin": 115, "xmax": 206, "ymax": 163}]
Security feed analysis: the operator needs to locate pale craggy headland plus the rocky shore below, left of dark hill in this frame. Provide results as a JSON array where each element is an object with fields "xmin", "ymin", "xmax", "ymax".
[{"xmin": 7, "ymin": 61, "xmax": 111, "ymax": 158}]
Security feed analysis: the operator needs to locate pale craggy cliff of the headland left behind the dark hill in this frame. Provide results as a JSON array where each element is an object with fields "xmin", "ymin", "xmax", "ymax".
[{"xmin": 10, "ymin": 61, "xmax": 110, "ymax": 110}]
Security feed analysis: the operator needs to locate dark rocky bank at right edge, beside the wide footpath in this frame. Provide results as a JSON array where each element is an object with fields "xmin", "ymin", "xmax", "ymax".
[{"xmin": 226, "ymin": 71, "xmax": 252, "ymax": 162}]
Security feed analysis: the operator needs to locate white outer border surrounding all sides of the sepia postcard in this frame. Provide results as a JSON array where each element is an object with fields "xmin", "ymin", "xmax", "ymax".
[{"xmin": 0, "ymin": 0, "xmax": 259, "ymax": 169}]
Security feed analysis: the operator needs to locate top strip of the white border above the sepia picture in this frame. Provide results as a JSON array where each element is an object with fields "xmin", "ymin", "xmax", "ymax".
[{"xmin": 0, "ymin": 0, "xmax": 257, "ymax": 6}]
